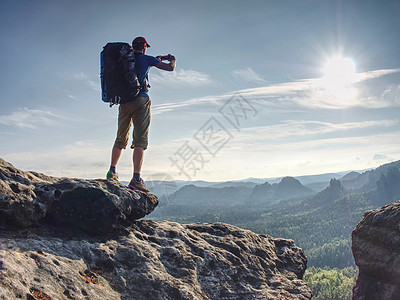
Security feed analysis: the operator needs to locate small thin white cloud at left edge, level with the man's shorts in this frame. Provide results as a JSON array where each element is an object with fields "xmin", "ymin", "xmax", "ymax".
[{"xmin": 0, "ymin": 107, "xmax": 63, "ymax": 129}]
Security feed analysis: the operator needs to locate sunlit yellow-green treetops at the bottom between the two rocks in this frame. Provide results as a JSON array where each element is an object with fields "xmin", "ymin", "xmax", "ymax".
[{"xmin": 303, "ymin": 267, "xmax": 358, "ymax": 300}]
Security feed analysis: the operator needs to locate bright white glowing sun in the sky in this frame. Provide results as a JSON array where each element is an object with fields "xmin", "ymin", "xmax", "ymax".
[{"xmin": 319, "ymin": 56, "xmax": 357, "ymax": 100}]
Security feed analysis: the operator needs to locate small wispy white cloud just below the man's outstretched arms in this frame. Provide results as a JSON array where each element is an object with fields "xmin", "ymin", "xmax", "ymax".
[{"xmin": 150, "ymin": 69, "xmax": 212, "ymax": 87}]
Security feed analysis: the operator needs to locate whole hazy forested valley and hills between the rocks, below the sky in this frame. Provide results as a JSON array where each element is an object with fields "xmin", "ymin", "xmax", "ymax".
[{"xmin": 149, "ymin": 161, "xmax": 400, "ymax": 299}]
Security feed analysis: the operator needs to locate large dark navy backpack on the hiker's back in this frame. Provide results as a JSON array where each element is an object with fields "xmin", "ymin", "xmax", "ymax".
[{"xmin": 100, "ymin": 42, "xmax": 141, "ymax": 107}]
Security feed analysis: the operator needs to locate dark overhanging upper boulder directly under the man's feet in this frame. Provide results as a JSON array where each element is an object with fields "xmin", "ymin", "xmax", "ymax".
[{"xmin": 0, "ymin": 159, "xmax": 158, "ymax": 234}]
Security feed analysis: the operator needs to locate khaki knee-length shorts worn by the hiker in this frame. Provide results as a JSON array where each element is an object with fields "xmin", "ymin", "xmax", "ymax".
[{"xmin": 114, "ymin": 96, "xmax": 151, "ymax": 149}]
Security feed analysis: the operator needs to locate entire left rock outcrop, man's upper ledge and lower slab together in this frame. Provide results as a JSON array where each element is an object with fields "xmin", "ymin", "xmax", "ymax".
[{"xmin": 0, "ymin": 161, "xmax": 311, "ymax": 300}]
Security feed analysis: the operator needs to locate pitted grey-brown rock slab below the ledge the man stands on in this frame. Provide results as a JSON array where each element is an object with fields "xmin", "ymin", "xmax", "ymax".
[{"xmin": 0, "ymin": 221, "xmax": 311, "ymax": 300}]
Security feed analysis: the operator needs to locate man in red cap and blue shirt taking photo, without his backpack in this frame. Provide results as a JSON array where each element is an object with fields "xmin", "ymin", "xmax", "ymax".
[{"xmin": 107, "ymin": 37, "xmax": 176, "ymax": 192}]
